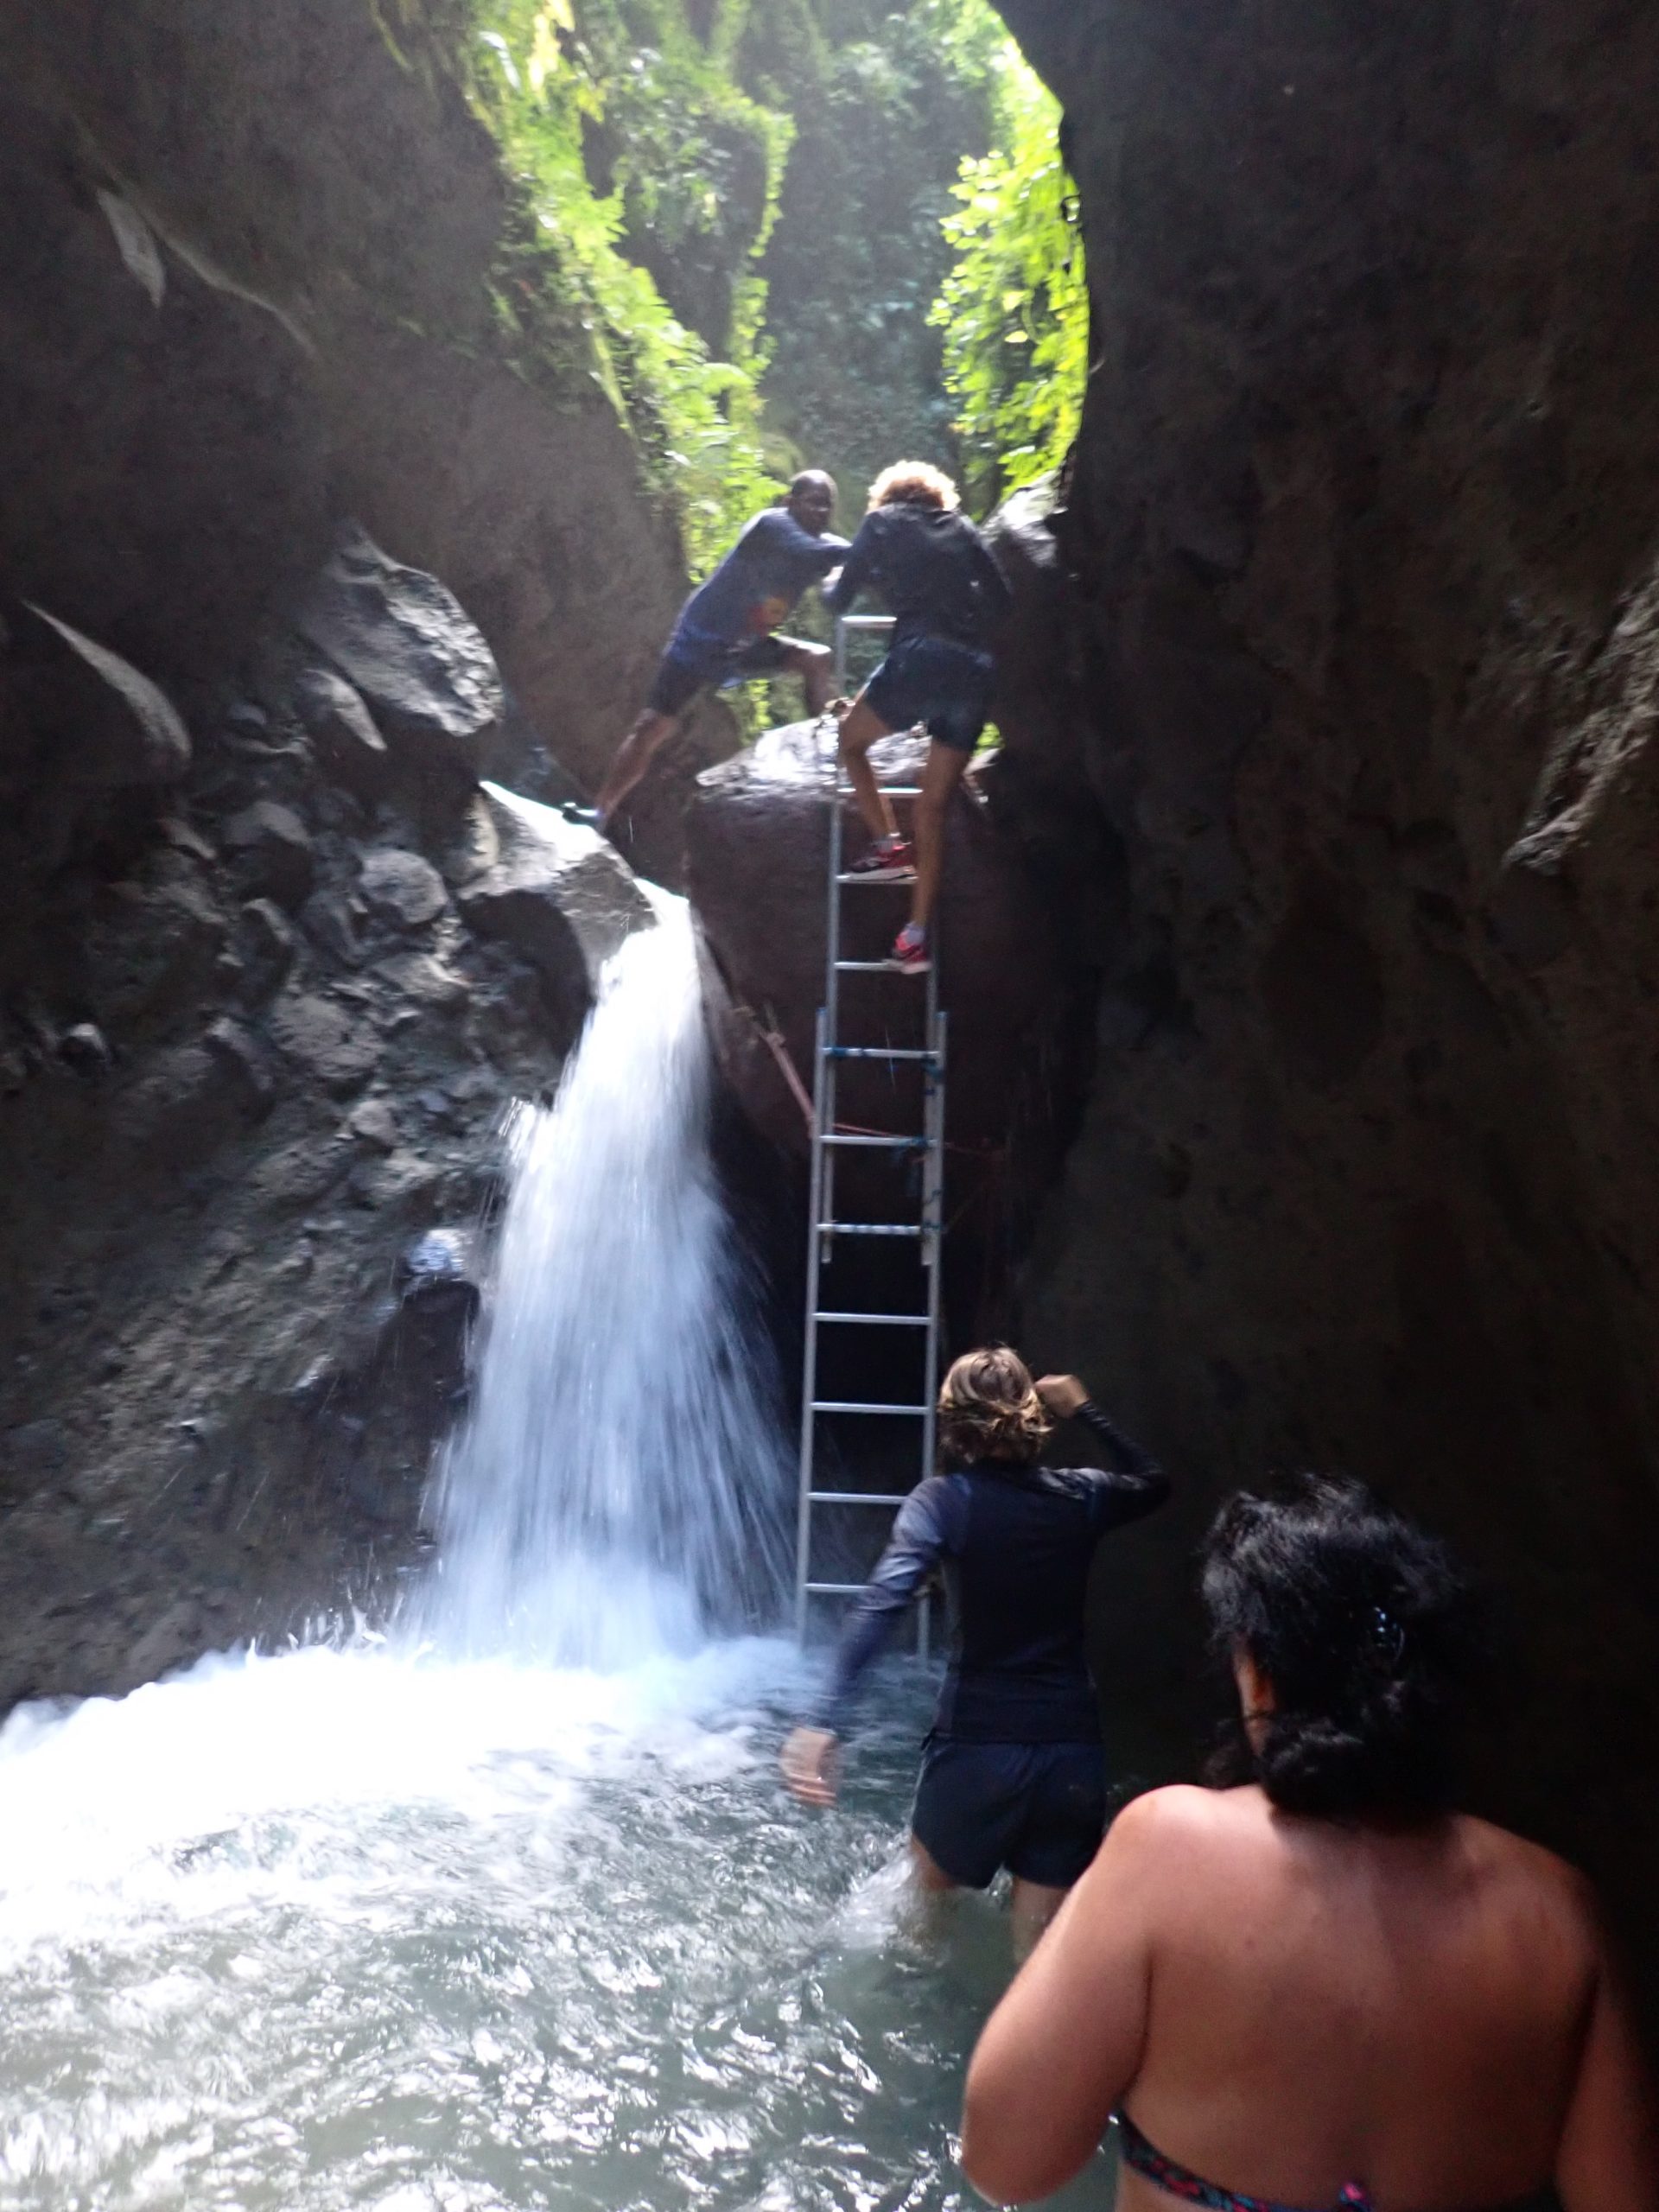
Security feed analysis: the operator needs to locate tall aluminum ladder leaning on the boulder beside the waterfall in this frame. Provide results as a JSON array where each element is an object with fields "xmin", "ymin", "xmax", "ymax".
[{"xmin": 794, "ymin": 615, "xmax": 947, "ymax": 1656}]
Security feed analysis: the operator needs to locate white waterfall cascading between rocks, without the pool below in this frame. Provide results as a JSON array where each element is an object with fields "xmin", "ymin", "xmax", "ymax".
[{"xmin": 423, "ymin": 893, "xmax": 785, "ymax": 1668}]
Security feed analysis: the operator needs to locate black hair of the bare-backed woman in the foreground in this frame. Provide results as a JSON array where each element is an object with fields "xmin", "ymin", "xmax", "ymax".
[{"xmin": 1204, "ymin": 1476, "xmax": 1478, "ymax": 1818}]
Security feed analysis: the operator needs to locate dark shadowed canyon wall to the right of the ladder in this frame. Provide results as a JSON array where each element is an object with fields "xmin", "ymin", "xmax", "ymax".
[{"xmin": 986, "ymin": 0, "xmax": 1659, "ymax": 1991}]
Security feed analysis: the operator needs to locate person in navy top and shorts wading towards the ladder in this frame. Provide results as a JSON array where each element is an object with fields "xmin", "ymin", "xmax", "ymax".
[{"xmin": 783, "ymin": 1344, "xmax": 1170, "ymax": 1953}]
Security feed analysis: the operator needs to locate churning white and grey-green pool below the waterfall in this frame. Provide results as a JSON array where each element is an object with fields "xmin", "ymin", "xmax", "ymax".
[{"xmin": 0, "ymin": 1642, "xmax": 1109, "ymax": 2212}]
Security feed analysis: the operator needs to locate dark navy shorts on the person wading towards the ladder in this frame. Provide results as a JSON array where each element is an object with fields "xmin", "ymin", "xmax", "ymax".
[{"xmin": 909, "ymin": 1737, "xmax": 1106, "ymax": 1889}]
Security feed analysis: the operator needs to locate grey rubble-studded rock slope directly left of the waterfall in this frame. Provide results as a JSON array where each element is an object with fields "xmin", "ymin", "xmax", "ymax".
[{"xmin": 0, "ymin": 546, "xmax": 655, "ymax": 1706}]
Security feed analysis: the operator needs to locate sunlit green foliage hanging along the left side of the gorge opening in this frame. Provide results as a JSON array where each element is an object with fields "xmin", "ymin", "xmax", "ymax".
[{"xmin": 457, "ymin": 0, "xmax": 790, "ymax": 564}]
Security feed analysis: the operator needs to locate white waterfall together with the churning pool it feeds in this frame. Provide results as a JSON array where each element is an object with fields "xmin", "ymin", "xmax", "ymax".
[{"xmin": 0, "ymin": 844, "xmax": 1109, "ymax": 2212}]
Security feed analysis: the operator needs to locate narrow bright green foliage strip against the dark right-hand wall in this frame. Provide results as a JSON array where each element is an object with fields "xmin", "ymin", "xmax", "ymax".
[{"xmin": 931, "ymin": 51, "xmax": 1089, "ymax": 509}]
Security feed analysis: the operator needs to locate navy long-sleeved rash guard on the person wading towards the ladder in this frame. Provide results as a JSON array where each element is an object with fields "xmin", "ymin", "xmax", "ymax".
[{"xmin": 812, "ymin": 1400, "xmax": 1170, "ymax": 1743}]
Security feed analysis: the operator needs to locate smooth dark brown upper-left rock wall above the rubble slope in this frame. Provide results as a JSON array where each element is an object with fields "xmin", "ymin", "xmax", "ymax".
[{"xmin": 0, "ymin": 0, "xmax": 703, "ymax": 814}]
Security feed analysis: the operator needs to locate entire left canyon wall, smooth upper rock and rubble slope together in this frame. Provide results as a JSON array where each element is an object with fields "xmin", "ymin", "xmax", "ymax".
[{"xmin": 0, "ymin": 0, "xmax": 683, "ymax": 1706}]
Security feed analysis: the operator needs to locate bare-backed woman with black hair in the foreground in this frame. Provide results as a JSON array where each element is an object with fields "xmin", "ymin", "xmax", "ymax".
[{"xmin": 963, "ymin": 1482, "xmax": 1659, "ymax": 2212}]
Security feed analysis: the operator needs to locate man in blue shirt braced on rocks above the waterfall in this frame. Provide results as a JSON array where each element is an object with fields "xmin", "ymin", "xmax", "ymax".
[{"xmin": 595, "ymin": 469, "xmax": 847, "ymax": 830}]
